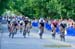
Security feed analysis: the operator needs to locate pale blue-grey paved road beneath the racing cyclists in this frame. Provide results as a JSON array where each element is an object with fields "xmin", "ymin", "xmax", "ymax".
[{"xmin": 0, "ymin": 25, "xmax": 75, "ymax": 49}]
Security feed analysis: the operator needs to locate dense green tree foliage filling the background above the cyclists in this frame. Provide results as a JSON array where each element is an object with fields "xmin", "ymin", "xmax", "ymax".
[{"xmin": 0, "ymin": 0, "xmax": 75, "ymax": 19}]
